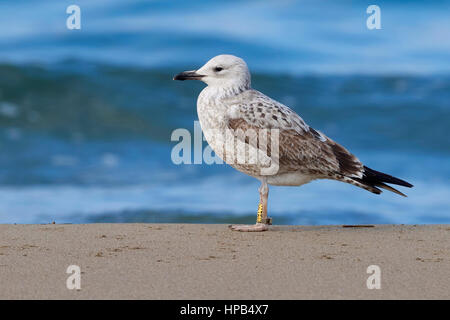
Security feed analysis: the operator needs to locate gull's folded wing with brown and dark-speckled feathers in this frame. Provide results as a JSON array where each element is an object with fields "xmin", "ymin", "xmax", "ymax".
[{"xmin": 228, "ymin": 90, "xmax": 363, "ymax": 178}]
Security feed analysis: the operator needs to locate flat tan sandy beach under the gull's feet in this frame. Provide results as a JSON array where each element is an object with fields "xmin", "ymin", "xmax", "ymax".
[{"xmin": 0, "ymin": 224, "xmax": 450, "ymax": 299}]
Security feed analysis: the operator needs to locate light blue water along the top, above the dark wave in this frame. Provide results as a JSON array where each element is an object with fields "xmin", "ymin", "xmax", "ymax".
[{"xmin": 0, "ymin": 0, "xmax": 450, "ymax": 74}]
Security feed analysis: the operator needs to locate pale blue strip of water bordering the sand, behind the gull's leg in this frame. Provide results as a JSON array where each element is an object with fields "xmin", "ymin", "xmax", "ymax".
[{"xmin": 0, "ymin": 176, "xmax": 450, "ymax": 224}]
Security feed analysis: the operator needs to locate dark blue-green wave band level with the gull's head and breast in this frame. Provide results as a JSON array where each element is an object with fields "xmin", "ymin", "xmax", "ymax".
[{"xmin": 0, "ymin": 62, "xmax": 450, "ymax": 153}]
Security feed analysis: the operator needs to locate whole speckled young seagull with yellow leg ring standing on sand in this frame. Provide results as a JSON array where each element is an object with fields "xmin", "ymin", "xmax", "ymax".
[{"xmin": 173, "ymin": 54, "xmax": 412, "ymax": 231}]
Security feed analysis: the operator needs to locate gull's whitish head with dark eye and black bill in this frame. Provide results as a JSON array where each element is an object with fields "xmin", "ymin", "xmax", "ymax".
[{"xmin": 173, "ymin": 54, "xmax": 250, "ymax": 89}]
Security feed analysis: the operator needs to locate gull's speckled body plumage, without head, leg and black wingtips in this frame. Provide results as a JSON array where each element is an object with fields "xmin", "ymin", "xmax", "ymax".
[{"xmin": 197, "ymin": 87, "xmax": 372, "ymax": 190}]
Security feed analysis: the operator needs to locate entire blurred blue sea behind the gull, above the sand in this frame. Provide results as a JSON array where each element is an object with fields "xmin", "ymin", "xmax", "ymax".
[{"xmin": 0, "ymin": 0, "xmax": 450, "ymax": 225}]
